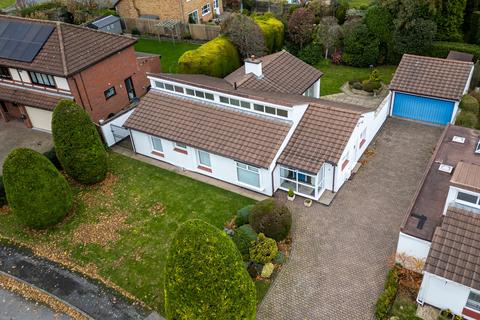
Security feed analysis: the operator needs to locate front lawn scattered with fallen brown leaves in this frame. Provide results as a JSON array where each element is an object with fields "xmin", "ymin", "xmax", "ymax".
[{"xmin": 0, "ymin": 153, "xmax": 254, "ymax": 313}]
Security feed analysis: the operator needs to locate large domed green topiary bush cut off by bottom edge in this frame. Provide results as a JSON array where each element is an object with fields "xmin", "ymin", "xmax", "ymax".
[{"xmin": 165, "ymin": 220, "xmax": 256, "ymax": 320}]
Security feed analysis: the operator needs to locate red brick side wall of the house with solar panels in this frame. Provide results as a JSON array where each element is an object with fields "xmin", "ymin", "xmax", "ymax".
[{"xmin": 68, "ymin": 46, "xmax": 160, "ymax": 122}]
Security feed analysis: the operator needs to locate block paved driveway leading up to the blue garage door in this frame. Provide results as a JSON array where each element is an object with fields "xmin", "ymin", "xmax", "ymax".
[{"xmin": 257, "ymin": 119, "xmax": 443, "ymax": 320}]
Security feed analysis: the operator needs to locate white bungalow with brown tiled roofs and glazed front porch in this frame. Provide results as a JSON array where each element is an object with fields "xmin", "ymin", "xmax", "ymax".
[{"xmin": 124, "ymin": 52, "xmax": 388, "ymax": 200}]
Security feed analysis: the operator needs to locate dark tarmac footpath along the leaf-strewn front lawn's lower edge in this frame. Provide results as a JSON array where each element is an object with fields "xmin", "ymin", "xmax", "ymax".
[{"xmin": 0, "ymin": 244, "xmax": 147, "ymax": 320}]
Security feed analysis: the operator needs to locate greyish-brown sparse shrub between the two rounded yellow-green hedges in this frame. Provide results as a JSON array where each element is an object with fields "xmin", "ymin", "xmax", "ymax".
[{"xmin": 221, "ymin": 13, "xmax": 267, "ymax": 58}]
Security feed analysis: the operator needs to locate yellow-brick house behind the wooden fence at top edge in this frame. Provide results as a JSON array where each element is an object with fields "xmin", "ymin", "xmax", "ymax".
[{"xmin": 114, "ymin": 0, "xmax": 223, "ymax": 23}]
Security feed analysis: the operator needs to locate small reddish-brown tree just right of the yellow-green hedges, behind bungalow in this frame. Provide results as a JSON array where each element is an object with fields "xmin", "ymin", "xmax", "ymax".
[{"xmin": 288, "ymin": 8, "xmax": 315, "ymax": 49}]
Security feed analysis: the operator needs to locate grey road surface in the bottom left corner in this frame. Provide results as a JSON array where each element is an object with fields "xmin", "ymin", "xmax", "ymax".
[{"xmin": 0, "ymin": 287, "xmax": 71, "ymax": 320}]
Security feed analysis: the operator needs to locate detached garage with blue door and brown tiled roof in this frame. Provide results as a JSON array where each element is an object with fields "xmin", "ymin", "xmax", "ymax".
[{"xmin": 390, "ymin": 54, "xmax": 473, "ymax": 125}]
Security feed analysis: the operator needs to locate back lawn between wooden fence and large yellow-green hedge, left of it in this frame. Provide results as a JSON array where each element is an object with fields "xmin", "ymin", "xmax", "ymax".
[{"xmin": 135, "ymin": 37, "xmax": 200, "ymax": 73}]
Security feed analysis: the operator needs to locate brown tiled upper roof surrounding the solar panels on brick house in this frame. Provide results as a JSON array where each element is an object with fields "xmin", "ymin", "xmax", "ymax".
[{"xmin": 0, "ymin": 16, "xmax": 137, "ymax": 76}]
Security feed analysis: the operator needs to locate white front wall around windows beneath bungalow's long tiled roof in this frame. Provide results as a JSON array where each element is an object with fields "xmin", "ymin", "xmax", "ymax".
[{"xmin": 130, "ymin": 130, "xmax": 273, "ymax": 196}]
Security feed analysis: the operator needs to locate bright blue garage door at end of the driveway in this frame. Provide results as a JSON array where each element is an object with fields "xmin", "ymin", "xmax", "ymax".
[{"xmin": 392, "ymin": 93, "xmax": 455, "ymax": 125}]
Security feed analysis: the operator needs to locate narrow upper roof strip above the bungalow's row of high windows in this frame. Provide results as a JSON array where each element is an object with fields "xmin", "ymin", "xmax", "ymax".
[{"xmin": 153, "ymin": 73, "xmax": 326, "ymax": 107}]
